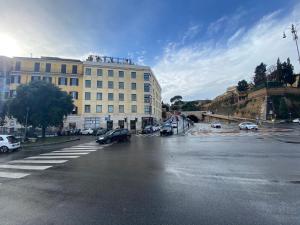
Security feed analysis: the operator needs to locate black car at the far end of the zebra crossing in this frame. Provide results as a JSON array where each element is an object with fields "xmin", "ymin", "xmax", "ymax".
[{"xmin": 96, "ymin": 129, "xmax": 131, "ymax": 144}]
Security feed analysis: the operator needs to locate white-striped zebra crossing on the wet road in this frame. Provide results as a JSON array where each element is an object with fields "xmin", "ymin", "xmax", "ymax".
[{"xmin": 0, "ymin": 142, "xmax": 103, "ymax": 184}]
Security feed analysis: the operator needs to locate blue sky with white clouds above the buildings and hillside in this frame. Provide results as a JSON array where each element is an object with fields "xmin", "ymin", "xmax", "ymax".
[{"xmin": 0, "ymin": 0, "xmax": 300, "ymax": 101}]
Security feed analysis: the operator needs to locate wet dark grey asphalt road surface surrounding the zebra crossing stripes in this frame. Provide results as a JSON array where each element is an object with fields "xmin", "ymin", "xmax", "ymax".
[{"xmin": 0, "ymin": 126, "xmax": 300, "ymax": 225}]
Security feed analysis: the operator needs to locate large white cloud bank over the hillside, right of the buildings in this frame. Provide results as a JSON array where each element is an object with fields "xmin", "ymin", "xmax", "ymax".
[{"xmin": 153, "ymin": 5, "xmax": 300, "ymax": 101}]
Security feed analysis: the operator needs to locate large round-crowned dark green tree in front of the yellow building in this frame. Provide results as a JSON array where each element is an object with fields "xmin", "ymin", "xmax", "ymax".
[{"xmin": 9, "ymin": 81, "xmax": 74, "ymax": 137}]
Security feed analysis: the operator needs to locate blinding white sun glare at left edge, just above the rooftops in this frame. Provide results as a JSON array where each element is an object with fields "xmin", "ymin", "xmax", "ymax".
[{"xmin": 0, "ymin": 33, "xmax": 20, "ymax": 57}]
